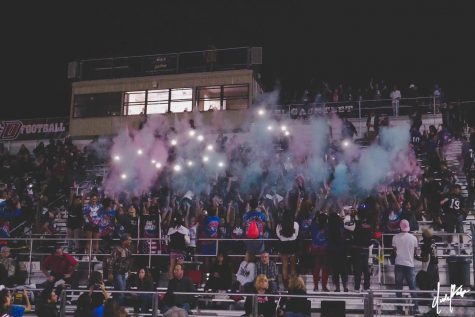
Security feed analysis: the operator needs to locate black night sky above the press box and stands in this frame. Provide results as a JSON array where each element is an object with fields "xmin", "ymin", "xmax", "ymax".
[{"xmin": 0, "ymin": 0, "xmax": 475, "ymax": 119}]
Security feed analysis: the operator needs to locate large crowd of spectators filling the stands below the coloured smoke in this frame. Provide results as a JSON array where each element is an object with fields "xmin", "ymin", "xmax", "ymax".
[{"xmin": 0, "ymin": 107, "xmax": 475, "ymax": 316}]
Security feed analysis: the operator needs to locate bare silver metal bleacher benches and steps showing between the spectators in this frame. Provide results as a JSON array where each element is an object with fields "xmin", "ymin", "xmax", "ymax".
[{"xmin": 3, "ymin": 111, "xmax": 475, "ymax": 317}]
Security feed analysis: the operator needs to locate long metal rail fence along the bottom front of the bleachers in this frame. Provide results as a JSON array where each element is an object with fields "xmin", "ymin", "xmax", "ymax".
[{"xmin": 6, "ymin": 288, "xmax": 468, "ymax": 317}]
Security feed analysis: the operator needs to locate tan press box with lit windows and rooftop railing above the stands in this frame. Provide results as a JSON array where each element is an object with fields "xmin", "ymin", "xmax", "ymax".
[{"xmin": 68, "ymin": 47, "xmax": 262, "ymax": 139}]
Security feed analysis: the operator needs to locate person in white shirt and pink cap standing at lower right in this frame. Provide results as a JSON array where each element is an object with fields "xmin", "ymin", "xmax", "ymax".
[{"xmin": 393, "ymin": 219, "xmax": 419, "ymax": 314}]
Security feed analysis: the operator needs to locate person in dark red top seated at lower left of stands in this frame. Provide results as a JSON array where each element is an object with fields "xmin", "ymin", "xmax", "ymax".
[{"xmin": 41, "ymin": 244, "xmax": 79, "ymax": 289}]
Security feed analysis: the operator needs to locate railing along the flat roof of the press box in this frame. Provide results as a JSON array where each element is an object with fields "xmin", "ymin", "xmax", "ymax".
[{"xmin": 78, "ymin": 47, "xmax": 252, "ymax": 80}]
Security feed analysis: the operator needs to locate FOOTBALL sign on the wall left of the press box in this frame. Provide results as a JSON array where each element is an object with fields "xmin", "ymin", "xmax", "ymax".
[{"xmin": 0, "ymin": 118, "xmax": 69, "ymax": 141}]
